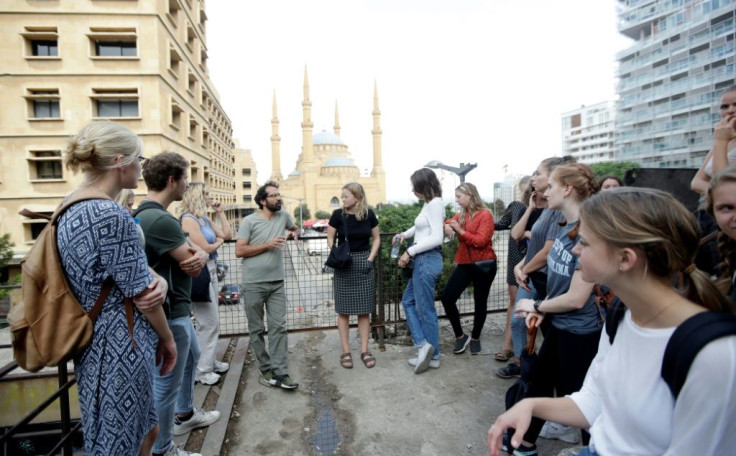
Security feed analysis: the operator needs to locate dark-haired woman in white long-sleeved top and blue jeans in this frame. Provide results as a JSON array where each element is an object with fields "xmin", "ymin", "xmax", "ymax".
[{"xmin": 394, "ymin": 168, "xmax": 445, "ymax": 374}]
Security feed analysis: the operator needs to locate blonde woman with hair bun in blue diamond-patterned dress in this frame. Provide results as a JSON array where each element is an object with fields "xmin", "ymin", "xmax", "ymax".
[{"xmin": 57, "ymin": 121, "xmax": 176, "ymax": 456}]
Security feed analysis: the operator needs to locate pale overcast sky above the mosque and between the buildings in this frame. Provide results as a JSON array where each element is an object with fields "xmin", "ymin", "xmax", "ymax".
[{"xmin": 206, "ymin": 0, "xmax": 631, "ymax": 201}]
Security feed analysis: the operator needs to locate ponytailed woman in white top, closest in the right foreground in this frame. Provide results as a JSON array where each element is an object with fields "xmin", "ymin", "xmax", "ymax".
[{"xmin": 488, "ymin": 188, "xmax": 736, "ymax": 456}]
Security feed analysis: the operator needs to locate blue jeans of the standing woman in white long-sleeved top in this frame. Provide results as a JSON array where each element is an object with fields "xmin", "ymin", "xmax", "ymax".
[{"xmin": 401, "ymin": 249, "xmax": 442, "ymax": 359}]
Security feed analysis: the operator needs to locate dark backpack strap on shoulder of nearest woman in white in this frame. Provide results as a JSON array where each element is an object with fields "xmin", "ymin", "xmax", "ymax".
[{"xmin": 662, "ymin": 311, "xmax": 736, "ymax": 400}]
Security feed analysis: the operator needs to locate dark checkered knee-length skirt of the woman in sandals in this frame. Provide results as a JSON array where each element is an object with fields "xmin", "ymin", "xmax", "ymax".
[{"xmin": 332, "ymin": 250, "xmax": 376, "ymax": 315}]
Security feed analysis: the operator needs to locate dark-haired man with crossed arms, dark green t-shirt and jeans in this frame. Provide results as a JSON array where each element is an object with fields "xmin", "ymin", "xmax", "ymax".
[{"xmin": 134, "ymin": 152, "xmax": 220, "ymax": 456}]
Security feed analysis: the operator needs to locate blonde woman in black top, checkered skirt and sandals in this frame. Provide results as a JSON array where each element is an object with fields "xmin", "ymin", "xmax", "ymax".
[{"xmin": 327, "ymin": 182, "xmax": 381, "ymax": 369}]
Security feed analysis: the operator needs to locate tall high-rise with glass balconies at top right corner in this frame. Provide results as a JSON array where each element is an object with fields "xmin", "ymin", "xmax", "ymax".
[{"xmin": 614, "ymin": 0, "xmax": 736, "ymax": 168}]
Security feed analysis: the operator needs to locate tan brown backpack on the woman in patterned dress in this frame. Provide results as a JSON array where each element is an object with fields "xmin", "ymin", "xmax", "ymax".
[{"xmin": 8, "ymin": 187, "xmax": 133, "ymax": 372}]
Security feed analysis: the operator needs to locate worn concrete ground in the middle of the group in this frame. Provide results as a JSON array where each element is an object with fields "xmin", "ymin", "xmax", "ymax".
[{"xmin": 221, "ymin": 314, "xmax": 572, "ymax": 456}]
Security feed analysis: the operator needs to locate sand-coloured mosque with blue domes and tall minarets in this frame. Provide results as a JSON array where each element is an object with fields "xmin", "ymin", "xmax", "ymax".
[{"xmin": 271, "ymin": 68, "xmax": 386, "ymax": 216}]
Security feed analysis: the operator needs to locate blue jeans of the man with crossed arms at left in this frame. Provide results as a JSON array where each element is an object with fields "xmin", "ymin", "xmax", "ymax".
[{"xmin": 153, "ymin": 316, "xmax": 199, "ymax": 453}]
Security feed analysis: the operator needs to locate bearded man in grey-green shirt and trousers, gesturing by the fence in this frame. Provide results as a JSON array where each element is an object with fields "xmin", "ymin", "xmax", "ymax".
[{"xmin": 235, "ymin": 182, "xmax": 299, "ymax": 390}]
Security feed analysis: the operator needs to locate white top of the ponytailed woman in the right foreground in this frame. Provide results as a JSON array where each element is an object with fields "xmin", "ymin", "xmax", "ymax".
[{"xmin": 568, "ymin": 311, "xmax": 736, "ymax": 456}]
